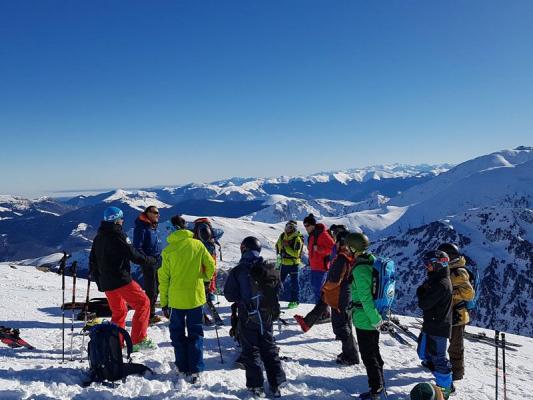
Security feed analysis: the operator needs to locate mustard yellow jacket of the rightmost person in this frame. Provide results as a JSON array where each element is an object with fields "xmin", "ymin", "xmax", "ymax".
[{"xmin": 450, "ymin": 256, "xmax": 476, "ymax": 325}]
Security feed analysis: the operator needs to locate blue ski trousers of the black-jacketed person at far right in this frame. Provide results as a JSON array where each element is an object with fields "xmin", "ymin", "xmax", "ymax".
[{"xmin": 418, "ymin": 332, "xmax": 452, "ymax": 388}]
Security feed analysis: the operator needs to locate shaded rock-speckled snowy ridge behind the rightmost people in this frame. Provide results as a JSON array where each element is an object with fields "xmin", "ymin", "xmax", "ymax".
[{"xmin": 373, "ymin": 206, "xmax": 533, "ymax": 336}]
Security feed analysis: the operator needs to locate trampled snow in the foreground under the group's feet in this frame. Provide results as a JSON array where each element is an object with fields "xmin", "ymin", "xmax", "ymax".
[{"xmin": 0, "ymin": 265, "xmax": 533, "ymax": 400}]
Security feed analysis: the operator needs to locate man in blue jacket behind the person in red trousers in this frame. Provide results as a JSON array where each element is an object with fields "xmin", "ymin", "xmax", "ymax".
[{"xmin": 133, "ymin": 206, "xmax": 161, "ymax": 324}]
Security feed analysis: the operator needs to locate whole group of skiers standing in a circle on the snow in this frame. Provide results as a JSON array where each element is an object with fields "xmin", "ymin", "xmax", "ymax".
[{"xmin": 90, "ymin": 206, "xmax": 474, "ymax": 400}]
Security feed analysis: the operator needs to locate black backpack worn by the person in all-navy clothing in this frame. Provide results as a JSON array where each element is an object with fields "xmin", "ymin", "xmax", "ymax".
[{"xmin": 248, "ymin": 259, "xmax": 281, "ymax": 333}]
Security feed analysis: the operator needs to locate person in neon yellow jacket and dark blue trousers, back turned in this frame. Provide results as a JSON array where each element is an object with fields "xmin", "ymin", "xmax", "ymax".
[{"xmin": 158, "ymin": 215, "xmax": 215, "ymax": 383}]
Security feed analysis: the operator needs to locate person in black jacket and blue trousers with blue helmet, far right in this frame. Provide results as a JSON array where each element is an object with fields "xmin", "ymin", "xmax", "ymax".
[{"xmin": 416, "ymin": 250, "xmax": 453, "ymax": 398}]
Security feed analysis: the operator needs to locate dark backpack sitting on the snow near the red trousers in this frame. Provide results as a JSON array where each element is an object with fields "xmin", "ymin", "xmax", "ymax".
[{"xmin": 85, "ymin": 322, "xmax": 152, "ymax": 386}]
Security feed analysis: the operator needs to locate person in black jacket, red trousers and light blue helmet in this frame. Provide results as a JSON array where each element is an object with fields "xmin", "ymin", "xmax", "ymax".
[{"xmin": 89, "ymin": 207, "xmax": 160, "ymax": 351}]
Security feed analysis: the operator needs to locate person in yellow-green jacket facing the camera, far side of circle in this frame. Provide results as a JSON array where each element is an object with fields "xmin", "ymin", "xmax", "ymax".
[{"xmin": 276, "ymin": 220, "xmax": 304, "ymax": 308}]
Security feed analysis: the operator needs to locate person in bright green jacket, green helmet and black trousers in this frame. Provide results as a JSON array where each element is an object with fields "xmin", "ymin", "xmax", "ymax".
[{"xmin": 345, "ymin": 233, "xmax": 386, "ymax": 400}]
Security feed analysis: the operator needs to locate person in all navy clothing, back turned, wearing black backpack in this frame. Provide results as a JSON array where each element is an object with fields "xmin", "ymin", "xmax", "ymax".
[{"xmin": 224, "ymin": 236, "xmax": 286, "ymax": 397}]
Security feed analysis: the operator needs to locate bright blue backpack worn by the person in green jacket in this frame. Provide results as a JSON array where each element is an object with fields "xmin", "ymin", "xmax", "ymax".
[{"xmin": 356, "ymin": 257, "xmax": 396, "ymax": 319}]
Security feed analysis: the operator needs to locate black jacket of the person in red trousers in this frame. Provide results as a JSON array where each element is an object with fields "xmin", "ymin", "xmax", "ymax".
[{"xmin": 89, "ymin": 221, "xmax": 158, "ymax": 292}]
